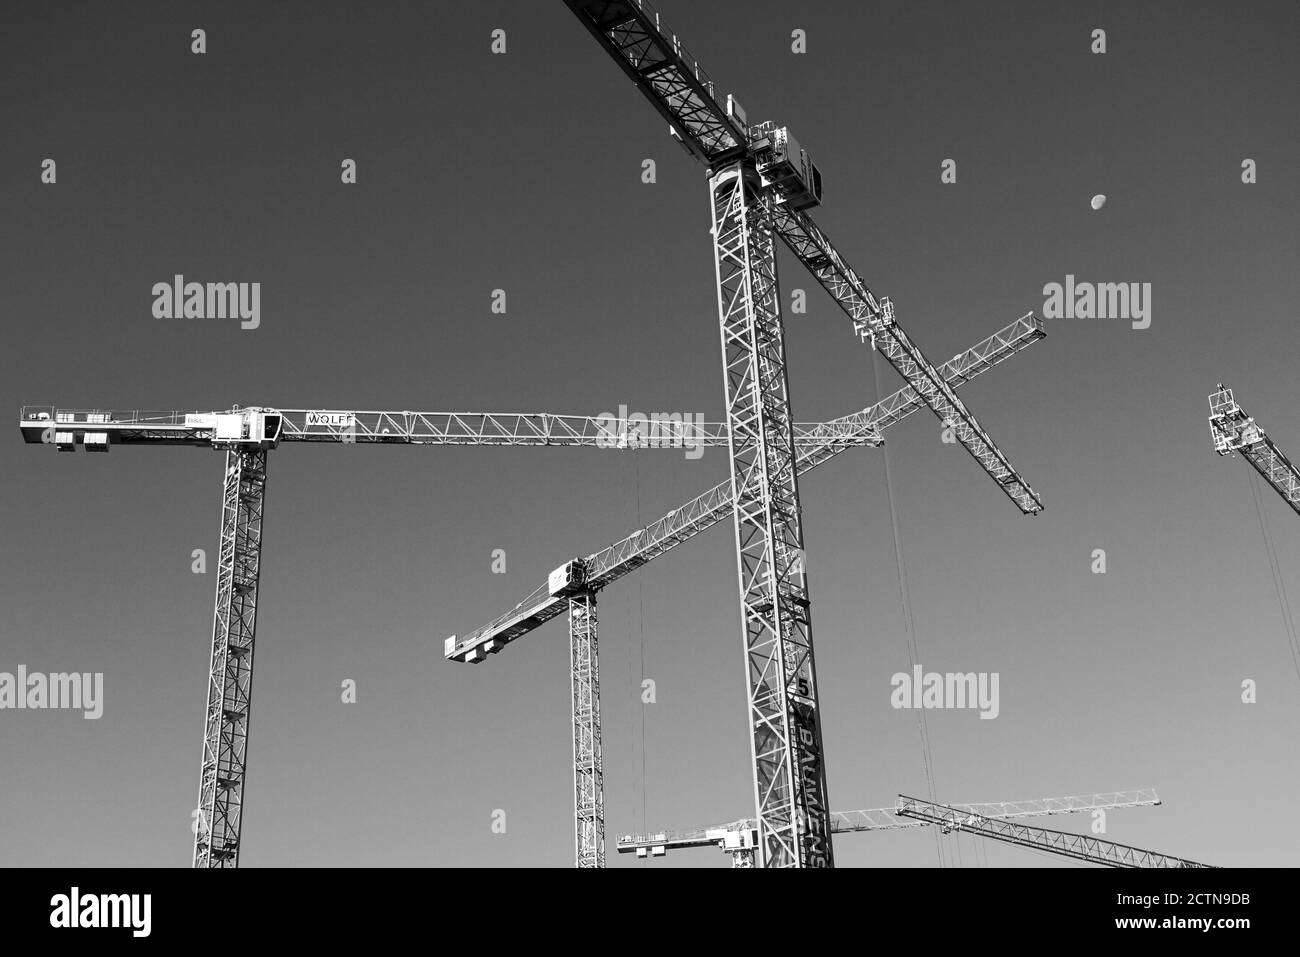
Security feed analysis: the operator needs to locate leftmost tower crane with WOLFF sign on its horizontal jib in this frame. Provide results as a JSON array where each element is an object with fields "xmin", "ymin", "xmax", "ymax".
[{"xmin": 18, "ymin": 406, "xmax": 881, "ymax": 867}]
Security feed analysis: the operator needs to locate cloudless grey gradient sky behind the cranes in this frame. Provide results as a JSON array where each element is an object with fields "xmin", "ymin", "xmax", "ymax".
[{"xmin": 0, "ymin": 0, "xmax": 1300, "ymax": 866}]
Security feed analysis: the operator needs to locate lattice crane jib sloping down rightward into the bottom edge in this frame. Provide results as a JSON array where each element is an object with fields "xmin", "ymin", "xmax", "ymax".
[{"xmin": 894, "ymin": 794, "xmax": 1213, "ymax": 867}]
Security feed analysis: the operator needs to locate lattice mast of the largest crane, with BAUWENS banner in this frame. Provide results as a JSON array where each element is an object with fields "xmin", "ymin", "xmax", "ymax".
[{"xmin": 710, "ymin": 161, "xmax": 833, "ymax": 867}]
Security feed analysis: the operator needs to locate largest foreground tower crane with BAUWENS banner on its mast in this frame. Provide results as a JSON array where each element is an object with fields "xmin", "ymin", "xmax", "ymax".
[{"xmin": 548, "ymin": 0, "xmax": 1043, "ymax": 867}]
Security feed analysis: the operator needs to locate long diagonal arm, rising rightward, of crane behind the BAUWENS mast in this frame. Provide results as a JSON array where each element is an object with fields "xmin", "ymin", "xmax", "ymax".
[{"xmin": 446, "ymin": 313, "xmax": 1047, "ymax": 662}]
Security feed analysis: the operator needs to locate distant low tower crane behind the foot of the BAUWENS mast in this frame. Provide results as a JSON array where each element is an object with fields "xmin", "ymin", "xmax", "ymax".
[{"xmin": 618, "ymin": 788, "xmax": 1160, "ymax": 867}]
